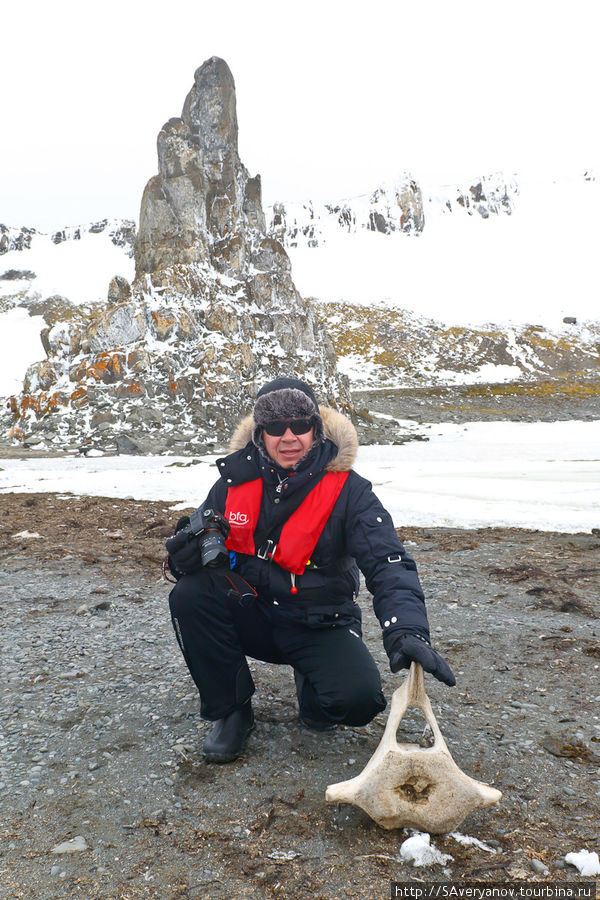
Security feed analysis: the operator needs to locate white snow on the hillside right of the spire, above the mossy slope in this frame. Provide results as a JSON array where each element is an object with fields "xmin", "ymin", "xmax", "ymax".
[{"xmin": 270, "ymin": 174, "xmax": 600, "ymax": 329}]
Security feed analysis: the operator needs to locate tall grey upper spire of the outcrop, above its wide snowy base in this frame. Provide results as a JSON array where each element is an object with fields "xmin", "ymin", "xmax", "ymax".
[{"xmin": 136, "ymin": 56, "xmax": 265, "ymax": 276}]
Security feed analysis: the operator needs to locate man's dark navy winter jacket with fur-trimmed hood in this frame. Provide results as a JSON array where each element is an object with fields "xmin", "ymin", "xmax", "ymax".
[{"xmin": 193, "ymin": 407, "xmax": 429, "ymax": 652}]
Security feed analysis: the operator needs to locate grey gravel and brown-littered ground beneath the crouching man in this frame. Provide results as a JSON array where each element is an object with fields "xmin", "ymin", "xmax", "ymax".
[{"xmin": 0, "ymin": 494, "xmax": 600, "ymax": 900}]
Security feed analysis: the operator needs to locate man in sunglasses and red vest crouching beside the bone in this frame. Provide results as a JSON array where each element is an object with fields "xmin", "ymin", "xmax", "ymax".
[{"xmin": 167, "ymin": 378, "xmax": 455, "ymax": 763}]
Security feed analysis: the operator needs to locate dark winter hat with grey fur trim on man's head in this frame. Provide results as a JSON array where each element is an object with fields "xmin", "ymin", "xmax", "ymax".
[{"xmin": 252, "ymin": 378, "xmax": 325, "ymax": 456}]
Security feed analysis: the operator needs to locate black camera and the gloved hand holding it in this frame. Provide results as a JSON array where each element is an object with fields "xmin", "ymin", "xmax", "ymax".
[{"xmin": 166, "ymin": 508, "xmax": 230, "ymax": 575}]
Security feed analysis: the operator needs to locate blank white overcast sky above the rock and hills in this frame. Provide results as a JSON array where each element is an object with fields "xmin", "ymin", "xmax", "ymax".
[{"xmin": 0, "ymin": 0, "xmax": 600, "ymax": 231}]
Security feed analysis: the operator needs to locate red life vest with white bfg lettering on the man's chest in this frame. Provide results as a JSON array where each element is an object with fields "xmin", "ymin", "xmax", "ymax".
[{"xmin": 225, "ymin": 472, "xmax": 349, "ymax": 575}]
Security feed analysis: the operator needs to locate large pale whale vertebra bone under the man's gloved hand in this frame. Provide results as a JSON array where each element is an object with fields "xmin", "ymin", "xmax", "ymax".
[{"xmin": 325, "ymin": 663, "xmax": 502, "ymax": 834}]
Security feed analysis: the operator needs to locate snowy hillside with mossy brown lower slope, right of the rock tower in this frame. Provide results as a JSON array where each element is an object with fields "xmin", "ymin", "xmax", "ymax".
[{"xmin": 269, "ymin": 173, "xmax": 600, "ymax": 390}]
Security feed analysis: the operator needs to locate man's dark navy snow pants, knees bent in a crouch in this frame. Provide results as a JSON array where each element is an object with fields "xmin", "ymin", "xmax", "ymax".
[{"xmin": 169, "ymin": 569, "xmax": 386, "ymax": 725}]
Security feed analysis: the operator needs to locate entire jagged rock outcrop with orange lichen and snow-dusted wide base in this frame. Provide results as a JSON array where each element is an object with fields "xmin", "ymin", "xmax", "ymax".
[{"xmin": 5, "ymin": 57, "xmax": 349, "ymax": 452}]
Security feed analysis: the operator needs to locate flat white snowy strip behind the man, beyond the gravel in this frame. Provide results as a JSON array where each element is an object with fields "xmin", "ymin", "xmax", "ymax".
[{"xmin": 0, "ymin": 421, "xmax": 600, "ymax": 532}]
